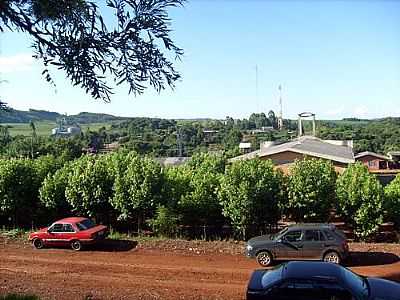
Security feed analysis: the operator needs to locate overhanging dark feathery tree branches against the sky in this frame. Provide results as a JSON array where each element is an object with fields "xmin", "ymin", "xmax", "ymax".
[{"xmin": 0, "ymin": 0, "xmax": 185, "ymax": 102}]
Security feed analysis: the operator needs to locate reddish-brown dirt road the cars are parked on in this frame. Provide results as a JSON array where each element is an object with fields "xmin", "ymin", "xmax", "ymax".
[{"xmin": 0, "ymin": 243, "xmax": 400, "ymax": 299}]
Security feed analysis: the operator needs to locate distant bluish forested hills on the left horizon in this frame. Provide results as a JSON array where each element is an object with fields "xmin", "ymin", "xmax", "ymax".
[{"xmin": 0, "ymin": 109, "xmax": 128, "ymax": 124}]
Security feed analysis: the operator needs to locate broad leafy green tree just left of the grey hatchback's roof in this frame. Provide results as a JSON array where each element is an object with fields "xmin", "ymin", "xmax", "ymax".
[{"xmin": 218, "ymin": 159, "xmax": 283, "ymax": 238}]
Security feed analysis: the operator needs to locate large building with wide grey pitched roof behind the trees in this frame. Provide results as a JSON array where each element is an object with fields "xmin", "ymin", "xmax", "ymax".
[{"xmin": 230, "ymin": 136, "xmax": 355, "ymax": 172}]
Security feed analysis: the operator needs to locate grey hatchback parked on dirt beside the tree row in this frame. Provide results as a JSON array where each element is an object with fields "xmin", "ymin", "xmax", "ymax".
[{"xmin": 246, "ymin": 224, "xmax": 349, "ymax": 267}]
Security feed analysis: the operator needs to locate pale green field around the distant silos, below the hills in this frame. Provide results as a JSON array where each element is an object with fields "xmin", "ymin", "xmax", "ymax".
[{"xmin": 0, "ymin": 121, "xmax": 111, "ymax": 136}]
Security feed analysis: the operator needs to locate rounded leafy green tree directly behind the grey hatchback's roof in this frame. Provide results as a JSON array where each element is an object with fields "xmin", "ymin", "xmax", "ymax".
[{"xmin": 282, "ymin": 159, "xmax": 337, "ymax": 222}]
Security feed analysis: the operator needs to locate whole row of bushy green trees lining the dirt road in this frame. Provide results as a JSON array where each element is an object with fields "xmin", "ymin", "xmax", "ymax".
[{"xmin": 0, "ymin": 151, "xmax": 400, "ymax": 239}]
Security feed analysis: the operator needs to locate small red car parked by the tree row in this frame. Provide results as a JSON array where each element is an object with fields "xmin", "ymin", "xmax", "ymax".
[{"xmin": 29, "ymin": 217, "xmax": 107, "ymax": 251}]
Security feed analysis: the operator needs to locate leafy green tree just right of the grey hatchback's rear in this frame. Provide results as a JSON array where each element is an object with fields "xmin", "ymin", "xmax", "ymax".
[{"xmin": 337, "ymin": 163, "xmax": 384, "ymax": 239}]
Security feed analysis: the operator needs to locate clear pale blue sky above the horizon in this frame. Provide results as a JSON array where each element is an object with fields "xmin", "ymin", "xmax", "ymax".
[{"xmin": 0, "ymin": 0, "xmax": 400, "ymax": 119}]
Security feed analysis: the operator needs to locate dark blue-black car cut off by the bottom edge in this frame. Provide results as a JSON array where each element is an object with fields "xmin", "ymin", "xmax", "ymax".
[{"xmin": 246, "ymin": 261, "xmax": 400, "ymax": 300}]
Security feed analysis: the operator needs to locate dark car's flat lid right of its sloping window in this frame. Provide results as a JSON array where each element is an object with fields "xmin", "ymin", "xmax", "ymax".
[{"xmin": 367, "ymin": 278, "xmax": 400, "ymax": 300}]
